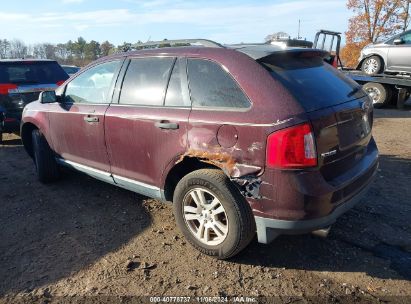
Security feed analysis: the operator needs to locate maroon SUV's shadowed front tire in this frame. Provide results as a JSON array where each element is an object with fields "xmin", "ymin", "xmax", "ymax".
[{"xmin": 31, "ymin": 130, "xmax": 60, "ymax": 183}]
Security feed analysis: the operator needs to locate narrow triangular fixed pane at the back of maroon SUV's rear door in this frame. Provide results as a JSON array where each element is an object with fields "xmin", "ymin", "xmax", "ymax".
[{"xmin": 165, "ymin": 58, "xmax": 191, "ymax": 107}]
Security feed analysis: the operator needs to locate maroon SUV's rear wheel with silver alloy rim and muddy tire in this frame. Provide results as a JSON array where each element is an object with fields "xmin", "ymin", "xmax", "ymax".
[{"xmin": 173, "ymin": 169, "xmax": 256, "ymax": 259}]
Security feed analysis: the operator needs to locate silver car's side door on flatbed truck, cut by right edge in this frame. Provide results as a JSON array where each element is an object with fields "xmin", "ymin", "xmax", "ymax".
[{"xmin": 388, "ymin": 32, "xmax": 411, "ymax": 72}]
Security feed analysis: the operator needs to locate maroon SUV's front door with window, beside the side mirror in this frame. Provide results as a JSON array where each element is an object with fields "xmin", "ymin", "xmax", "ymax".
[{"xmin": 49, "ymin": 59, "xmax": 122, "ymax": 172}]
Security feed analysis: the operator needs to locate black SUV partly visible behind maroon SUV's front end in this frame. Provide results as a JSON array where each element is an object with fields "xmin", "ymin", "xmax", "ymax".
[{"xmin": 0, "ymin": 59, "xmax": 69, "ymax": 140}]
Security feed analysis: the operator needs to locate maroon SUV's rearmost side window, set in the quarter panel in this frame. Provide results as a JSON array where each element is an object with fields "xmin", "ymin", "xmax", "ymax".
[{"xmin": 187, "ymin": 59, "xmax": 250, "ymax": 108}]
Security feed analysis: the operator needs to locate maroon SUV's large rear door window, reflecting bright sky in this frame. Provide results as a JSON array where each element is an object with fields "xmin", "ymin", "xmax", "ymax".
[{"xmin": 120, "ymin": 57, "xmax": 174, "ymax": 106}]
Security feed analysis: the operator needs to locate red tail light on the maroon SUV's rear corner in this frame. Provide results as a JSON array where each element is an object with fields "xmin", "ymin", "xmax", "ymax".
[{"xmin": 267, "ymin": 123, "xmax": 317, "ymax": 169}]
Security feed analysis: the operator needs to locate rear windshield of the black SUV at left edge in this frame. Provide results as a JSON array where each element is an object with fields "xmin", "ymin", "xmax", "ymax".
[{"xmin": 0, "ymin": 61, "xmax": 69, "ymax": 84}]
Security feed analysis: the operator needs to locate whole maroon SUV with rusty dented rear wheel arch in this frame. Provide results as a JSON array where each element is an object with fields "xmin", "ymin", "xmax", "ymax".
[{"xmin": 21, "ymin": 42, "xmax": 378, "ymax": 258}]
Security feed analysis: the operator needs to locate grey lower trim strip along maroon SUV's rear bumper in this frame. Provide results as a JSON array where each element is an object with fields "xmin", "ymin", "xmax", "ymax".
[{"xmin": 254, "ymin": 179, "xmax": 371, "ymax": 244}]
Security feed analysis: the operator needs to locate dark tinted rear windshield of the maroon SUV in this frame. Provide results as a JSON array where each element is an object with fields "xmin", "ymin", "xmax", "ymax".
[{"xmin": 259, "ymin": 52, "xmax": 365, "ymax": 112}]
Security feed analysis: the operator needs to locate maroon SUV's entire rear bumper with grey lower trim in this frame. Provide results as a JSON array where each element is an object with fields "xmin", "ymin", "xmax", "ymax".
[{"xmin": 253, "ymin": 139, "xmax": 378, "ymax": 243}]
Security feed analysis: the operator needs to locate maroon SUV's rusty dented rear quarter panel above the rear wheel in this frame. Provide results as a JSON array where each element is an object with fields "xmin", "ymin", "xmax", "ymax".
[{"xmin": 174, "ymin": 49, "xmax": 307, "ymax": 178}]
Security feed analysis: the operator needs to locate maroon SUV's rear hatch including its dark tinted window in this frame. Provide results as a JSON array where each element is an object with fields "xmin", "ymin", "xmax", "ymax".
[{"xmin": 257, "ymin": 49, "xmax": 373, "ymax": 186}]
